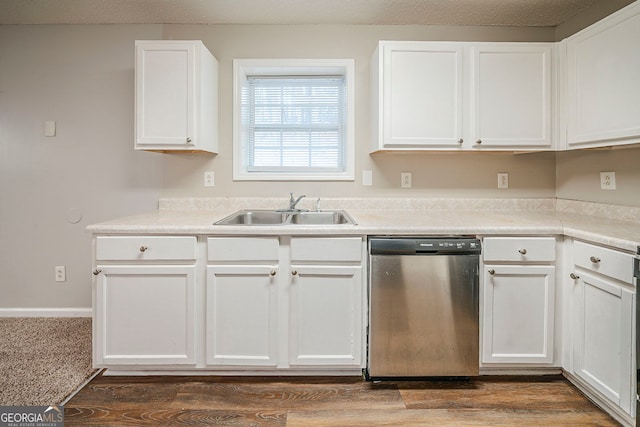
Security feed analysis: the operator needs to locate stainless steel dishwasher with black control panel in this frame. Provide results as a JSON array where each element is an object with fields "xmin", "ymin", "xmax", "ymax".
[{"xmin": 366, "ymin": 237, "xmax": 481, "ymax": 379}]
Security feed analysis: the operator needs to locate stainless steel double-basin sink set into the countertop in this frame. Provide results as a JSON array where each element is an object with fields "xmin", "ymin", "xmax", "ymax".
[{"xmin": 214, "ymin": 209, "xmax": 356, "ymax": 225}]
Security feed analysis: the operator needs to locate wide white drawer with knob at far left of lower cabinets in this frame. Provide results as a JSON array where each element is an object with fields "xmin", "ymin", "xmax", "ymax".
[{"xmin": 96, "ymin": 236, "xmax": 196, "ymax": 261}]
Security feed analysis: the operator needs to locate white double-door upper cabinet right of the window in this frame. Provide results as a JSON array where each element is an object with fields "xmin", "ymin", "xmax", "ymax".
[{"xmin": 371, "ymin": 41, "xmax": 553, "ymax": 151}]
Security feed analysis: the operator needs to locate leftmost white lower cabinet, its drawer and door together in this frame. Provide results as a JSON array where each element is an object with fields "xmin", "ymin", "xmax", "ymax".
[{"xmin": 93, "ymin": 236, "xmax": 197, "ymax": 368}]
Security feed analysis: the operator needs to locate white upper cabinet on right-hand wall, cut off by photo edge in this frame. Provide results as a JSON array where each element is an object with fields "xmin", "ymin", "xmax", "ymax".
[{"xmin": 566, "ymin": 2, "xmax": 640, "ymax": 148}]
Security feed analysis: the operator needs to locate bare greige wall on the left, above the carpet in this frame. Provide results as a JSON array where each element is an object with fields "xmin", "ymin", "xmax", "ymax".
[{"xmin": 0, "ymin": 25, "xmax": 162, "ymax": 308}]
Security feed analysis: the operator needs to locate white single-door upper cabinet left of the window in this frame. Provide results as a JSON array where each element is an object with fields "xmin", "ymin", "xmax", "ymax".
[{"xmin": 135, "ymin": 40, "xmax": 218, "ymax": 153}]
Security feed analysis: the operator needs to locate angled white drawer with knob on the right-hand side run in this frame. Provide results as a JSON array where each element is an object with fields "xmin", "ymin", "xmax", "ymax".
[{"xmin": 573, "ymin": 242, "xmax": 633, "ymax": 284}]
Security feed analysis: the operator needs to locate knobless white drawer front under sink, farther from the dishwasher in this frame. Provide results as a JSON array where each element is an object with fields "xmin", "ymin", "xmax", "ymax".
[{"xmin": 207, "ymin": 237, "xmax": 279, "ymax": 262}]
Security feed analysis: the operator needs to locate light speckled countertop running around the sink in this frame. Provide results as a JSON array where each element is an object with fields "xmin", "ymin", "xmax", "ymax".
[{"xmin": 87, "ymin": 198, "xmax": 640, "ymax": 253}]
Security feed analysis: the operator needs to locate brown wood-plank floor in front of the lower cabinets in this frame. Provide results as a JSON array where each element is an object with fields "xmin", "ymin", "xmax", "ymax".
[{"xmin": 64, "ymin": 376, "xmax": 619, "ymax": 427}]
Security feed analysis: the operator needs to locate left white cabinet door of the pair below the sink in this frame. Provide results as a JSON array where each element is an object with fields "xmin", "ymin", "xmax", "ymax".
[{"xmin": 206, "ymin": 265, "xmax": 278, "ymax": 366}]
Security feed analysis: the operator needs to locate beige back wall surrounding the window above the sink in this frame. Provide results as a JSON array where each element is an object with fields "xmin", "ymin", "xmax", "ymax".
[{"xmin": 163, "ymin": 25, "xmax": 555, "ymax": 201}]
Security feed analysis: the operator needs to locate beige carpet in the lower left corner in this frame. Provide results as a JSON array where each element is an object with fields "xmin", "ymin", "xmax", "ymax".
[{"xmin": 0, "ymin": 317, "xmax": 95, "ymax": 406}]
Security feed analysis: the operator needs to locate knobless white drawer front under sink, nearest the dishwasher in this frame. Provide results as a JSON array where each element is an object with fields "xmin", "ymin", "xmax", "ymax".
[{"xmin": 291, "ymin": 237, "xmax": 362, "ymax": 262}]
